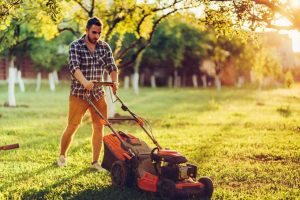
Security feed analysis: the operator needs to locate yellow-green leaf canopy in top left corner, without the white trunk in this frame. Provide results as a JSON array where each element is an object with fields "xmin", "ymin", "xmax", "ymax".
[{"xmin": 0, "ymin": 0, "xmax": 64, "ymax": 52}]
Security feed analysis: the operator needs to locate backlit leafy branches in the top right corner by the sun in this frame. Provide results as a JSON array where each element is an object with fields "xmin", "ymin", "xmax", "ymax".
[{"xmin": 211, "ymin": 0, "xmax": 300, "ymax": 30}]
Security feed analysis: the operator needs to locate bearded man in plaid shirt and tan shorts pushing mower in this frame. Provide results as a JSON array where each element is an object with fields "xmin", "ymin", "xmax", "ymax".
[{"xmin": 57, "ymin": 17, "xmax": 118, "ymax": 170}]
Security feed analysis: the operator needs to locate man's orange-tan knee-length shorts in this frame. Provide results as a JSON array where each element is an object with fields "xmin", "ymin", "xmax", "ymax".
[{"xmin": 68, "ymin": 95, "xmax": 107, "ymax": 126}]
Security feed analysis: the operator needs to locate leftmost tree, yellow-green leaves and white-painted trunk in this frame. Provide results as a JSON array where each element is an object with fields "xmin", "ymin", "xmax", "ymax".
[{"xmin": 0, "ymin": 0, "xmax": 63, "ymax": 106}]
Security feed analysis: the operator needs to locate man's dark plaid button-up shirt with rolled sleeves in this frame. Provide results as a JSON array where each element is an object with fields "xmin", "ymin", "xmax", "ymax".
[{"xmin": 69, "ymin": 35, "xmax": 118, "ymax": 100}]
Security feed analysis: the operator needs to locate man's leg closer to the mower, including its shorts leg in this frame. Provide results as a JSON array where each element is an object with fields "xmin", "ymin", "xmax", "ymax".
[{"xmin": 89, "ymin": 97, "xmax": 107, "ymax": 163}]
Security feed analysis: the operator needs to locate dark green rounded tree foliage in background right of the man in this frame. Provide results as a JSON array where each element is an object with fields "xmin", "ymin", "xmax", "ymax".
[{"xmin": 141, "ymin": 14, "xmax": 208, "ymax": 73}]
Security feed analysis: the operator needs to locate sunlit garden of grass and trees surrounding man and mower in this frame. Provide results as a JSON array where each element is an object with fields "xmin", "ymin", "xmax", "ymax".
[{"xmin": 0, "ymin": 0, "xmax": 300, "ymax": 199}]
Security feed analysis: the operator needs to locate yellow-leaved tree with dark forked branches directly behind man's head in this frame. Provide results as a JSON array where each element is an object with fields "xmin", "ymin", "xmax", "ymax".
[{"xmin": 38, "ymin": 0, "xmax": 202, "ymax": 68}]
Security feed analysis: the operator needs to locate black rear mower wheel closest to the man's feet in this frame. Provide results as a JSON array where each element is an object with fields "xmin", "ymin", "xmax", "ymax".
[{"xmin": 110, "ymin": 160, "xmax": 132, "ymax": 187}]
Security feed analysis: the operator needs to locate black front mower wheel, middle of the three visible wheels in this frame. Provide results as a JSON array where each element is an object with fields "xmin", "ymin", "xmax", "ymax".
[{"xmin": 158, "ymin": 179, "xmax": 176, "ymax": 199}]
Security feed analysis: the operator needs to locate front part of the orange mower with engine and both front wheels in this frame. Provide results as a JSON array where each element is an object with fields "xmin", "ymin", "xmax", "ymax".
[{"xmin": 151, "ymin": 148, "xmax": 213, "ymax": 199}]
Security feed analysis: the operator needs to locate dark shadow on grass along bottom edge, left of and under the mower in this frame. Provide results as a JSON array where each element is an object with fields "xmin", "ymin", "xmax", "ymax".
[{"xmin": 22, "ymin": 169, "xmax": 159, "ymax": 200}]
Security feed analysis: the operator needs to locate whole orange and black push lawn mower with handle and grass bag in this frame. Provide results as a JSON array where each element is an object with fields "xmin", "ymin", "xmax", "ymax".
[{"xmin": 86, "ymin": 82, "xmax": 213, "ymax": 199}]
